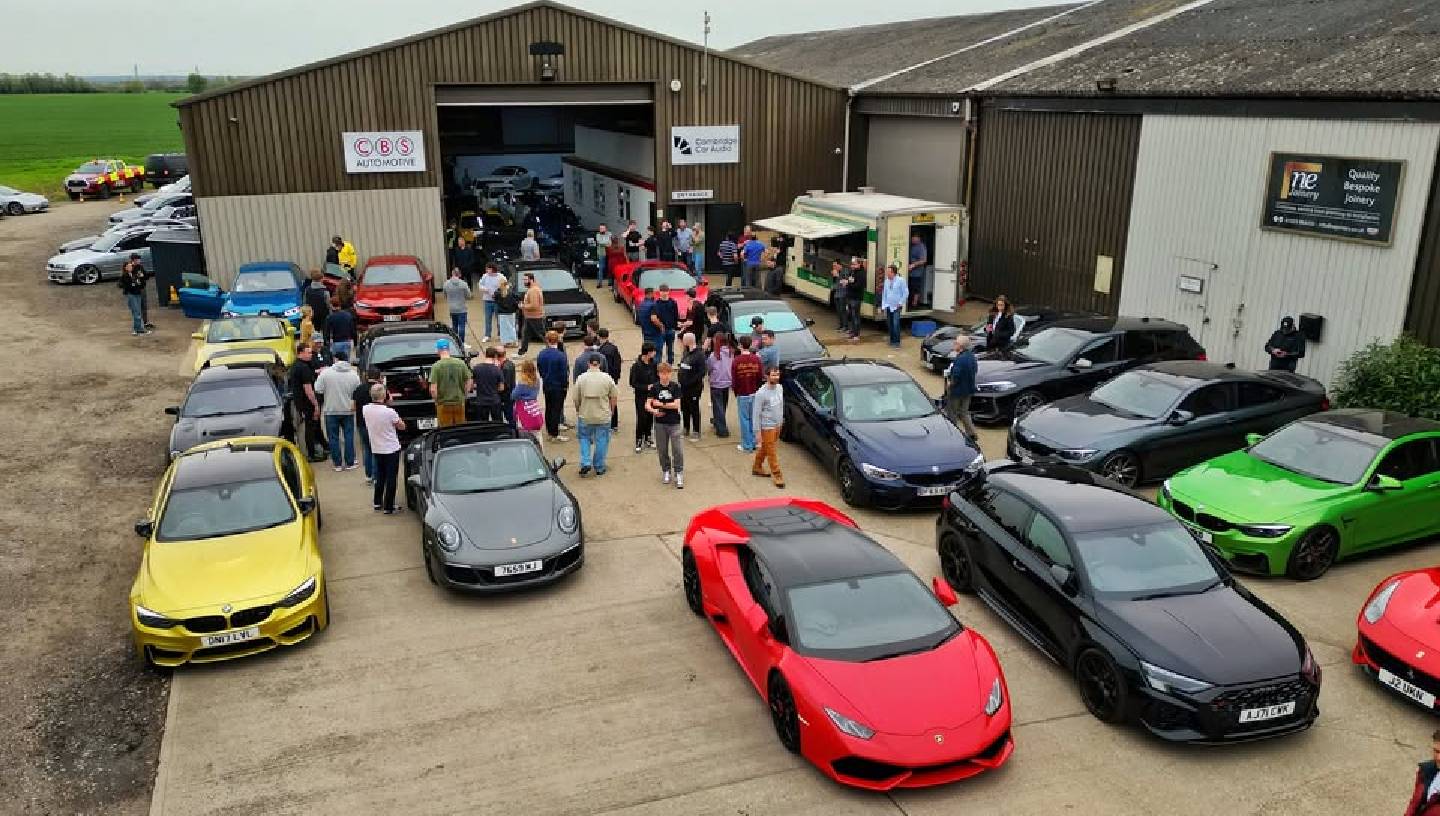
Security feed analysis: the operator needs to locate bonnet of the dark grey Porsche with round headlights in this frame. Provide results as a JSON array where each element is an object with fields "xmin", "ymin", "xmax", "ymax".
[{"xmin": 435, "ymin": 479, "xmax": 558, "ymax": 550}]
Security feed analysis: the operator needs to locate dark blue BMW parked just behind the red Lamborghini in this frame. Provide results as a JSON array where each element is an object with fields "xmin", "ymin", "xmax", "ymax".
[{"xmin": 782, "ymin": 360, "xmax": 985, "ymax": 507}]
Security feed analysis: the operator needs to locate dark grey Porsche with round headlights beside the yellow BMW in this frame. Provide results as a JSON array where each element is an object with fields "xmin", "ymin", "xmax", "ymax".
[{"xmin": 405, "ymin": 422, "xmax": 585, "ymax": 593}]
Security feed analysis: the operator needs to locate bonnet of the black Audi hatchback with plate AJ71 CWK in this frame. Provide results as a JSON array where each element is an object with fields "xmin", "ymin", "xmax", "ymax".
[{"xmin": 1100, "ymin": 586, "xmax": 1303, "ymax": 685}]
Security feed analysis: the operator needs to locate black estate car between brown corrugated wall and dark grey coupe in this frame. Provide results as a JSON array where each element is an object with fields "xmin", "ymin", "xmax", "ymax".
[{"xmin": 971, "ymin": 317, "xmax": 1205, "ymax": 422}]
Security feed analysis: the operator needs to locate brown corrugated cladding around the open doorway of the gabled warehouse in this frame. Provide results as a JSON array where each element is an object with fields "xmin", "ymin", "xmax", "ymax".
[{"xmin": 180, "ymin": 4, "xmax": 845, "ymax": 216}]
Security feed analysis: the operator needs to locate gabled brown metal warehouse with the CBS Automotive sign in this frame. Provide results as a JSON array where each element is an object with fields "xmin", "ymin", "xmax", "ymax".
[{"xmin": 177, "ymin": 1, "xmax": 847, "ymax": 289}]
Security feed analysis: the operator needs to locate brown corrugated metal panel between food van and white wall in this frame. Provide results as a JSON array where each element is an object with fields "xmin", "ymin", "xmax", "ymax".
[{"xmin": 966, "ymin": 107, "xmax": 1140, "ymax": 314}]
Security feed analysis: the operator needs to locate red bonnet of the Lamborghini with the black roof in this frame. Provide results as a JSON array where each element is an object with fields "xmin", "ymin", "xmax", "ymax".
[{"xmin": 805, "ymin": 630, "xmax": 999, "ymax": 735}]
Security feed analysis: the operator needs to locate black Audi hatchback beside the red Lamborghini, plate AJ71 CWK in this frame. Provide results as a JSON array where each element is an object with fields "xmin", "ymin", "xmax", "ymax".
[{"xmin": 936, "ymin": 465, "xmax": 1320, "ymax": 743}]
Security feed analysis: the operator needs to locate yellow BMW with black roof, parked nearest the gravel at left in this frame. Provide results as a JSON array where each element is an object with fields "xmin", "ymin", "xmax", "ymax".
[{"xmin": 130, "ymin": 436, "xmax": 330, "ymax": 668}]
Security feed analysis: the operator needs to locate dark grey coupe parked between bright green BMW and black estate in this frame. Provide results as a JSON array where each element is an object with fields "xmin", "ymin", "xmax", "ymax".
[{"xmin": 1007, "ymin": 361, "xmax": 1329, "ymax": 486}]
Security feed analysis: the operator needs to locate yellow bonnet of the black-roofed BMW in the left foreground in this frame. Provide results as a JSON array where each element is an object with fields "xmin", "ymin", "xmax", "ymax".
[{"xmin": 140, "ymin": 518, "xmax": 317, "ymax": 615}]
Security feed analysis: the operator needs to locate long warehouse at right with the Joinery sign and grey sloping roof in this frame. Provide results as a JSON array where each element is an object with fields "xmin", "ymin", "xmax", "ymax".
[{"xmin": 734, "ymin": 0, "xmax": 1440, "ymax": 381}]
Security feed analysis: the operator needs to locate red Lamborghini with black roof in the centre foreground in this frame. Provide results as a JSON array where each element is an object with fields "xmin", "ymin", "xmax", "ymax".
[{"xmin": 681, "ymin": 498, "xmax": 1015, "ymax": 790}]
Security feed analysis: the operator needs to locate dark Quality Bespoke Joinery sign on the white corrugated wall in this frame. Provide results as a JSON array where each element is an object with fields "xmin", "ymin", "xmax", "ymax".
[{"xmin": 1260, "ymin": 153, "xmax": 1405, "ymax": 246}]
